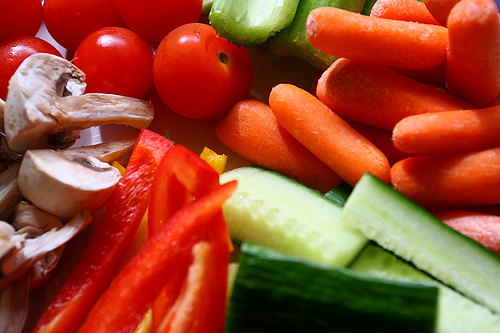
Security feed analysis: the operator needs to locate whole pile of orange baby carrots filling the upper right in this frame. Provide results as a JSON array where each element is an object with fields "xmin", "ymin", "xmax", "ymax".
[{"xmin": 217, "ymin": 0, "xmax": 500, "ymax": 253}]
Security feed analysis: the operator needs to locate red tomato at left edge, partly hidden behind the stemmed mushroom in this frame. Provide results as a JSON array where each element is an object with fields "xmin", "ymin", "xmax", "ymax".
[{"xmin": 0, "ymin": 36, "xmax": 62, "ymax": 99}]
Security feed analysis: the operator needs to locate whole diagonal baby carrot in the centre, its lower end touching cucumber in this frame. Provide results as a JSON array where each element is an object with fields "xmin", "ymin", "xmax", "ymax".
[{"xmin": 269, "ymin": 84, "xmax": 390, "ymax": 186}]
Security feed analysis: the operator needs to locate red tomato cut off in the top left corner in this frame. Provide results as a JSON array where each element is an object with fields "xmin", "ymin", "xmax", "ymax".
[{"xmin": 0, "ymin": 0, "xmax": 43, "ymax": 43}]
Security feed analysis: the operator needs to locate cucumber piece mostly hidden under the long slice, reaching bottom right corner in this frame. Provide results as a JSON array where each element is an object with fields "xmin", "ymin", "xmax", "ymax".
[{"xmin": 350, "ymin": 244, "xmax": 500, "ymax": 333}]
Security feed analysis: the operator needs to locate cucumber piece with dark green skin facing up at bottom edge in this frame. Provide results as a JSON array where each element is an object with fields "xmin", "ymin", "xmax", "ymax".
[{"xmin": 226, "ymin": 243, "xmax": 438, "ymax": 333}]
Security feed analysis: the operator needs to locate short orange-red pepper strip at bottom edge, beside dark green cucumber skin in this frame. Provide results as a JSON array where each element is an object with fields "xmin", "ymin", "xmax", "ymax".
[{"xmin": 156, "ymin": 242, "xmax": 229, "ymax": 333}]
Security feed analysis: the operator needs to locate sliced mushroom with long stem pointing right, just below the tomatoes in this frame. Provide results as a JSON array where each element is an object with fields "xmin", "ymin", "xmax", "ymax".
[{"xmin": 4, "ymin": 53, "xmax": 154, "ymax": 152}]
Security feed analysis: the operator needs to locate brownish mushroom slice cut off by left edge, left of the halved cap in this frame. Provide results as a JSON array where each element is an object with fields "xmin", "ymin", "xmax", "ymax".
[{"xmin": 0, "ymin": 162, "xmax": 23, "ymax": 220}]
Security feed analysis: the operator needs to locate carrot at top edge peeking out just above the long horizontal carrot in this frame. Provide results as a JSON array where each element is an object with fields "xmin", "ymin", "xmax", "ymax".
[{"xmin": 370, "ymin": 0, "xmax": 441, "ymax": 25}]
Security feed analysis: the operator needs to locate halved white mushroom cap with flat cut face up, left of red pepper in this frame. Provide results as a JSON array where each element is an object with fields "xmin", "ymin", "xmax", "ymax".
[{"xmin": 18, "ymin": 149, "xmax": 121, "ymax": 217}]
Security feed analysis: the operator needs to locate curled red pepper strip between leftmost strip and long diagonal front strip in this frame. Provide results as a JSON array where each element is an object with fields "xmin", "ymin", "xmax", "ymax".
[{"xmin": 148, "ymin": 145, "xmax": 219, "ymax": 236}]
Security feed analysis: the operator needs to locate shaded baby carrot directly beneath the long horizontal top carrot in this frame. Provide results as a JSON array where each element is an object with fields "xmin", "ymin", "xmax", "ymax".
[{"xmin": 316, "ymin": 58, "xmax": 475, "ymax": 131}]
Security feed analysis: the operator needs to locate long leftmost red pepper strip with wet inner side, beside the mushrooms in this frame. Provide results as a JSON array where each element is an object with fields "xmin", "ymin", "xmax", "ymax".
[{"xmin": 32, "ymin": 129, "xmax": 173, "ymax": 333}]
